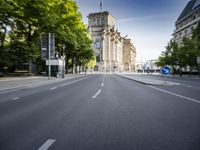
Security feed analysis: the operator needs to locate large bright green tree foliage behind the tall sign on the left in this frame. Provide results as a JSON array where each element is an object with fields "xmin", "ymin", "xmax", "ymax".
[{"xmin": 0, "ymin": 0, "xmax": 94, "ymax": 72}]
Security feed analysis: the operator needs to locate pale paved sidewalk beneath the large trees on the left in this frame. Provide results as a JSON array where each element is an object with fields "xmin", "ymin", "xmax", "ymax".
[{"xmin": 0, "ymin": 74, "xmax": 84, "ymax": 91}]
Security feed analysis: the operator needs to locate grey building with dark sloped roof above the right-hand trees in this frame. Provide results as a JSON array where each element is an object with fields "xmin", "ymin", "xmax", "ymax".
[{"xmin": 173, "ymin": 0, "xmax": 200, "ymax": 45}]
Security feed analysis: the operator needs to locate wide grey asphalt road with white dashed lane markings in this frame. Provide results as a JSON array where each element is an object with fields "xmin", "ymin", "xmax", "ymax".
[{"xmin": 0, "ymin": 75, "xmax": 200, "ymax": 150}]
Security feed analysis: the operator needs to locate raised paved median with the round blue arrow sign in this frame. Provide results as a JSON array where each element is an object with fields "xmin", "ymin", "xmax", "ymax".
[{"xmin": 115, "ymin": 74, "xmax": 180, "ymax": 86}]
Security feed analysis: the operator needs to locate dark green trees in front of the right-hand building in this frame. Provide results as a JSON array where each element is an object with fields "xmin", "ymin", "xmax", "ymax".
[{"xmin": 157, "ymin": 24, "xmax": 200, "ymax": 75}]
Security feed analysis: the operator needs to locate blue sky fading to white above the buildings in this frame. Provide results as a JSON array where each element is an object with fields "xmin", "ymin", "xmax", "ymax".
[{"xmin": 75, "ymin": 0, "xmax": 189, "ymax": 63}]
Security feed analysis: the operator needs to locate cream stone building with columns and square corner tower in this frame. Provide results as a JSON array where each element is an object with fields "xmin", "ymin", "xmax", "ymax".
[{"xmin": 88, "ymin": 11, "xmax": 136, "ymax": 72}]
